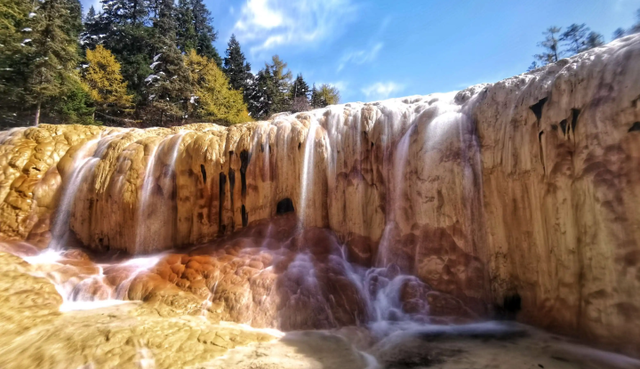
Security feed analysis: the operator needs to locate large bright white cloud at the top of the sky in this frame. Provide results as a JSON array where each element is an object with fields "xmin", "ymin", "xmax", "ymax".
[{"xmin": 233, "ymin": 0, "xmax": 354, "ymax": 53}]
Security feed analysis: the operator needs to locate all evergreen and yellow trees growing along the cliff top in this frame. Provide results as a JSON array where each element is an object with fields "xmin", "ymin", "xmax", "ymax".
[{"xmin": 0, "ymin": 0, "xmax": 640, "ymax": 127}]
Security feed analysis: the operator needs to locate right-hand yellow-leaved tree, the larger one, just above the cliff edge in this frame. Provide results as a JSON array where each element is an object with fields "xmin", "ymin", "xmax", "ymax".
[{"xmin": 185, "ymin": 50, "xmax": 252, "ymax": 124}]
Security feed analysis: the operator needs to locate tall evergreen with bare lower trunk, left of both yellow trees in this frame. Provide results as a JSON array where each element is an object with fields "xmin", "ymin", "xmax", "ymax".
[{"xmin": 28, "ymin": 0, "xmax": 80, "ymax": 125}]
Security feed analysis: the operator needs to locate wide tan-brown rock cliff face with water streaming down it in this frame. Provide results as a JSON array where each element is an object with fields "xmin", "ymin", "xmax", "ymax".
[{"xmin": 0, "ymin": 36, "xmax": 640, "ymax": 354}]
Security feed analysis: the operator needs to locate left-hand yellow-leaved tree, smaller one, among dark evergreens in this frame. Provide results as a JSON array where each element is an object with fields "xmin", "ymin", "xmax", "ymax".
[{"xmin": 84, "ymin": 45, "xmax": 133, "ymax": 114}]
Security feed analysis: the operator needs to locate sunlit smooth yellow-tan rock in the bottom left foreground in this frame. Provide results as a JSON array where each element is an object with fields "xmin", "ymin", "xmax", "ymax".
[{"xmin": 0, "ymin": 253, "xmax": 276, "ymax": 368}]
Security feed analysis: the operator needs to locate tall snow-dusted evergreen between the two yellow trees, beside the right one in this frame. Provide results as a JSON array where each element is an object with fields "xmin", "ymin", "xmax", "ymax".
[{"xmin": 145, "ymin": 0, "xmax": 192, "ymax": 125}]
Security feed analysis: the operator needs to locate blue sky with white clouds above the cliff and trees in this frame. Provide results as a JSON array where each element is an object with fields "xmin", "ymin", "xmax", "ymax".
[{"xmin": 82, "ymin": 0, "xmax": 640, "ymax": 102}]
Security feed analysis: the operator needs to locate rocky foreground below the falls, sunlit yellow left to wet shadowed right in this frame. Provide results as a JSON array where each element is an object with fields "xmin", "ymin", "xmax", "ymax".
[{"xmin": 0, "ymin": 244, "xmax": 640, "ymax": 369}]
